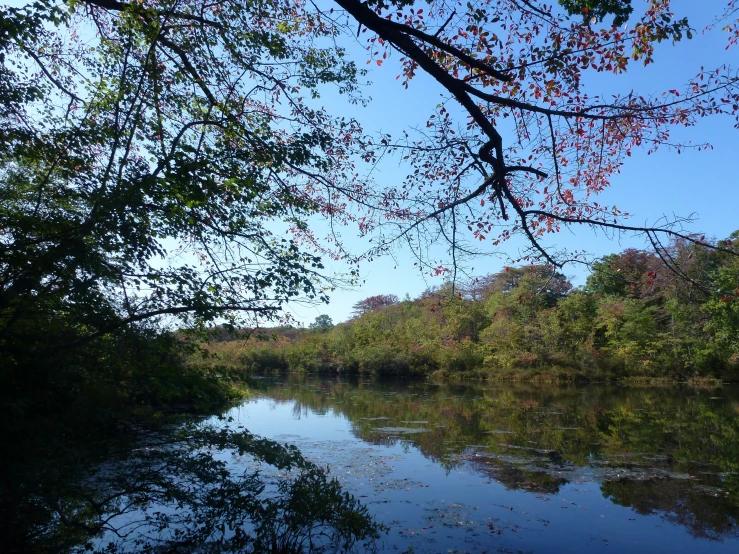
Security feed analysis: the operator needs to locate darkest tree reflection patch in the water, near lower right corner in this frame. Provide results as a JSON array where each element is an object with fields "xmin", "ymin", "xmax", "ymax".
[{"xmin": 601, "ymin": 479, "xmax": 739, "ymax": 540}]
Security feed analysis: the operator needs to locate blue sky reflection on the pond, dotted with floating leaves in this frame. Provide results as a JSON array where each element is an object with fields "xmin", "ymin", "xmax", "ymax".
[{"xmin": 227, "ymin": 388, "xmax": 739, "ymax": 553}]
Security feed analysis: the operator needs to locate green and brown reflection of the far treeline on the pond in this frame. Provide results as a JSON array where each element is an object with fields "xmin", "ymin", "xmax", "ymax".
[{"xmin": 249, "ymin": 376, "xmax": 739, "ymax": 551}]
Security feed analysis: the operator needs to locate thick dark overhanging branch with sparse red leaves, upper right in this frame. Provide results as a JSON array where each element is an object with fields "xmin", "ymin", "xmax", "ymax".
[{"xmin": 336, "ymin": 0, "xmax": 739, "ymax": 273}]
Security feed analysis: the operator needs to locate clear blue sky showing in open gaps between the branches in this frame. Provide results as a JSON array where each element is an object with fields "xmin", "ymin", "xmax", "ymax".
[{"xmin": 287, "ymin": 0, "xmax": 739, "ymax": 325}]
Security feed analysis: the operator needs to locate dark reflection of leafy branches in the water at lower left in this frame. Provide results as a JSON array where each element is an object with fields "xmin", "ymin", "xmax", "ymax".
[{"xmin": 5, "ymin": 425, "xmax": 382, "ymax": 554}]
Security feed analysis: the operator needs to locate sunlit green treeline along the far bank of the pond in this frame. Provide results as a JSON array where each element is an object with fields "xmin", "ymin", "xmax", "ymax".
[{"xmin": 209, "ymin": 232, "xmax": 739, "ymax": 381}]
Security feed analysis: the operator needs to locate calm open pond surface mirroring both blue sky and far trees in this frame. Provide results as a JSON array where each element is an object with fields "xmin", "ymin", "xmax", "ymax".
[{"xmin": 227, "ymin": 376, "xmax": 739, "ymax": 554}]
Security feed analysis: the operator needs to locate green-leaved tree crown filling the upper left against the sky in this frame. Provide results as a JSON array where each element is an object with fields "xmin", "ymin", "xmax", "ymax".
[{"xmin": 0, "ymin": 0, "xmax": 358, "ymax": 353}]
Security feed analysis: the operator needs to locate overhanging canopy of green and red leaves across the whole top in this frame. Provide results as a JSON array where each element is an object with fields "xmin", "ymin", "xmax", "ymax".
[{"xmin": 0, "ymin": 0, "xmax": 739, "ymax": 343}]
